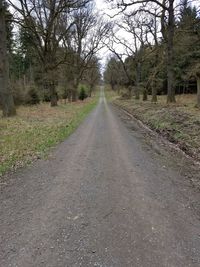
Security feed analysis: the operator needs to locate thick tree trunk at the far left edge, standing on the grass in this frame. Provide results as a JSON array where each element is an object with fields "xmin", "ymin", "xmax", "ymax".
[{"xmin": 0, "ymin": 0, "xmax": 16, "ymax": 117}]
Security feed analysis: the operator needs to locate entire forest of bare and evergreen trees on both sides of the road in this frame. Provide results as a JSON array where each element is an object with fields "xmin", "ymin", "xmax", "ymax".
[{"xmin": 0, "ymin": 0, "xmax": 200, "ymax": 116}]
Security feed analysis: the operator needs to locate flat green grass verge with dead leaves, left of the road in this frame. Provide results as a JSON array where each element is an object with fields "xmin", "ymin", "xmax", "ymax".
[{"xmin": 0, "ymin": 97, "xmax": 97, "ymax": 175}]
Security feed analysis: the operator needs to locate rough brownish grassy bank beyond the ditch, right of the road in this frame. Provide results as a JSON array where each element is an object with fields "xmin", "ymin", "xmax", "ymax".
[{"xmin": 112, "ymin": 95, "xmax": 200, "ymax": 160}]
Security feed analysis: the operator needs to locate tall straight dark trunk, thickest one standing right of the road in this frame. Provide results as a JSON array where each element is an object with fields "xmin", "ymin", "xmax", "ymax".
[{"xmin": 167, "ymin": 0, "xmax": 176, "ymax": 103}]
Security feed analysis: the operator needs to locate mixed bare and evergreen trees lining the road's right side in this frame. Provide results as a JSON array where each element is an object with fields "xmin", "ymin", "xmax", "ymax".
[{"xmin": 104, "ymin": 0, "xmax": 200, "ymax": 108}]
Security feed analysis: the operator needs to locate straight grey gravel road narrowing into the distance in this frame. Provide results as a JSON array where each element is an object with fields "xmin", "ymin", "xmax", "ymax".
[{"xmin": 0, "ymin": 92, "xmax": 200, "ymax": 267}]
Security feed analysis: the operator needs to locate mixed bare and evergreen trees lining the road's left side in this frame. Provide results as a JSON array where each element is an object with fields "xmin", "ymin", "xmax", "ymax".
[{"xmin": 0, "ymin": 0, "xmax": 110, "ymax": 116}]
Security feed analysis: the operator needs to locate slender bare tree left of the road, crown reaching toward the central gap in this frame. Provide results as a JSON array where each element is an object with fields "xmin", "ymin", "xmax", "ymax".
[{"xmin": 66, "ymin": 4, "xmax": 110, "ymax": 101}]
